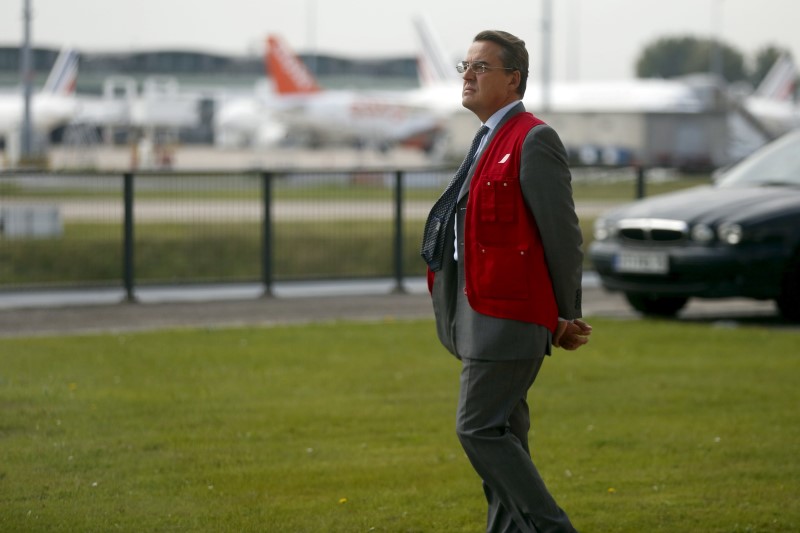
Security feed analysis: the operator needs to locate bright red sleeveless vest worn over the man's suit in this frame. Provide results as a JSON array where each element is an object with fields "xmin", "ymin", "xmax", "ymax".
[{"xmin": 459, "ymin": 113, "xmax": 558, "ymax": 331}]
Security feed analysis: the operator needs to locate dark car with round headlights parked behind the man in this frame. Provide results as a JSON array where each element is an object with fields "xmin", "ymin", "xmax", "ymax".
[{"xmin": 589, "ymin": 131, "xmax": 800, "ymax": 321}]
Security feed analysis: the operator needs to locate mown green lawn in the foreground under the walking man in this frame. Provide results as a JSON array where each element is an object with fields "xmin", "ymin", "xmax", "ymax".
[{"xmin": 0, "ymin": 319, "xmax": 800, "ymax": 533}]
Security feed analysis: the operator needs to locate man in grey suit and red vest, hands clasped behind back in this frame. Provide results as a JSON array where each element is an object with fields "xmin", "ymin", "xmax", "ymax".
[{"xmin": 422, "ymin": 31, "xmax": 591, "ymax": 533}]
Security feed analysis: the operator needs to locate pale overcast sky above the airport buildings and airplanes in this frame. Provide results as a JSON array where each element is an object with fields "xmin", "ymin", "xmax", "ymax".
[{"xmin": 0, "ymin": 0, "xmax": 800, "ymax": 81}]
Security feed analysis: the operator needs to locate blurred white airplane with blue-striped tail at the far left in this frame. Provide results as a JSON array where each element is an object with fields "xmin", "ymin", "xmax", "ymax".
[{"xmin": 0, "ymin": 48, "xmax": 78, "ymax": 142}]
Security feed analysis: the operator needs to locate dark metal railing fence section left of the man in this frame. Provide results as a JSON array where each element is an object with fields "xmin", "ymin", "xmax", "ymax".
[{"xmin": 0, "ymin": 169, "xmax": 452, "ymax": 300}]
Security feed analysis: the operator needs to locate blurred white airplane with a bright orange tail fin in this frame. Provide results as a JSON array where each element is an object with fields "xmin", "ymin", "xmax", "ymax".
[{"xmin": 215, "ymin": 35, "xmax": 438, "ymax": 148}]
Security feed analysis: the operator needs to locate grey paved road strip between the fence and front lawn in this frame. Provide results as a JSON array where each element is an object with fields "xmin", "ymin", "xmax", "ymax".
[{"xmin": 0, "ymin": 283, "xmax": 797, "ymax": 337}]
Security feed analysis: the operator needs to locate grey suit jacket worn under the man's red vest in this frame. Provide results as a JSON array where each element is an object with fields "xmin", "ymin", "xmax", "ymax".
[{"xmin": 432, "ymin": 103, "xmax": 583, "ymax": 360}]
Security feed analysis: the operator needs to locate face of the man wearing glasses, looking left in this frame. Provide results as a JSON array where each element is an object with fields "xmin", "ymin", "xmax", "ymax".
[{"xmin": 461, "ymin": 41, "xmax": 520, "ymax": 122}]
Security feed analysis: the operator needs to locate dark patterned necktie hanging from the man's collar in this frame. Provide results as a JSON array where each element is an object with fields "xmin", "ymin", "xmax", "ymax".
[{"xmin": 420, "ymin": 126, "xmax": 489, "ymax": 272}]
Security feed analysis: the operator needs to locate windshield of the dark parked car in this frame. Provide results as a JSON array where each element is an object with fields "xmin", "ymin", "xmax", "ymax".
[{"xmin": 717, "ymin": 131, "xmax": 800, "ymax": 187}]
